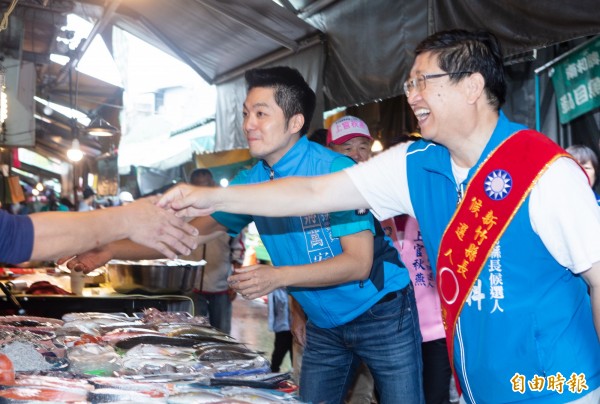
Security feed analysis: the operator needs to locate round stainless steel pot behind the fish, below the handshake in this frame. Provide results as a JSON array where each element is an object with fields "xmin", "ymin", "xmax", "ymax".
[{"xmin": 106, "ymin": 260, "xmax": 203, "ymax": 294}]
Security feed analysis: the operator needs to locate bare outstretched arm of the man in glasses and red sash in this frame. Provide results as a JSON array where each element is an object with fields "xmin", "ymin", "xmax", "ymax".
[{"xmin": 159, "ymin": 171, "xmax": 369, "ymax": 221}]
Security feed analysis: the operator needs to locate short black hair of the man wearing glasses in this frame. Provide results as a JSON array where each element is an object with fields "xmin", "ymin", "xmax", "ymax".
[{"xmin": 415, "ymin": 29, "xmax": 506, "ymax": 110}]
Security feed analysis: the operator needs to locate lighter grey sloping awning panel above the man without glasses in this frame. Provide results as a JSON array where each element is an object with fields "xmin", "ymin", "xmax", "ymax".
[{"xmin": 82, "ymin": 0, "xmax": 318, "ymax": 84}]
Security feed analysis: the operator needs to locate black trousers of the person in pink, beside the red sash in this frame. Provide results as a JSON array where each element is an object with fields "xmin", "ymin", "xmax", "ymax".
[{"xmin": 421, "ymin": 338, "xmax": 452, "ymax": 404}]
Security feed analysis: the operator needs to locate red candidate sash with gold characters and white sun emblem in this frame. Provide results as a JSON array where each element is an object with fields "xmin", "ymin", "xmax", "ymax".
[{"xmin": 436, "ymin": 130, "xmax": 570, "ymax": 392}]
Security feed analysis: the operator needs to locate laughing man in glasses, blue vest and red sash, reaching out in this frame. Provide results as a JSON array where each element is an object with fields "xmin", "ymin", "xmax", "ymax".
[{"xmin": 161, "ymin": 30, "xmax": 600, "ymax": 404}]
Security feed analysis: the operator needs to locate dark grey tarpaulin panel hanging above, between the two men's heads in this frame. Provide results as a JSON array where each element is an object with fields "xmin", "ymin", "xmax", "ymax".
[{"xmin": 309, "ymin": 0, "xmax": 428, "ymax": 109}]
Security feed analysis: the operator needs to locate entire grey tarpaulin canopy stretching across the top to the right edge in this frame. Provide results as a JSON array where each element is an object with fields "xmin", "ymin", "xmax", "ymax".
[{"xmin": 70, "ymin": 0, "xmax": 600, "ymax": 109}]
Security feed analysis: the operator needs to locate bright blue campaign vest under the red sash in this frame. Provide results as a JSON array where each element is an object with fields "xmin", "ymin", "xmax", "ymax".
[{"xmin": 407, "ymin": 113, "xmax": 600, "ymax": 403}]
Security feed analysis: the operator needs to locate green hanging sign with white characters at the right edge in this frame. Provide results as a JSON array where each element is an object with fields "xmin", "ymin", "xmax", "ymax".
[{"xmin": 549, "ymin": 37, "xmax": 600, "ymax": 124}]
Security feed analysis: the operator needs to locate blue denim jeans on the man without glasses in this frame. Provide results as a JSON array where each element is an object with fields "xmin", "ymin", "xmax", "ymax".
[{"xmin": 300, "ymin": 284, "xmax": 424, "ymax": 404}]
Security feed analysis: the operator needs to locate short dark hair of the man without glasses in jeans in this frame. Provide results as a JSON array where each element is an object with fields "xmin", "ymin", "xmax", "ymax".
[{"xmin": 245, "ymin": 66, "xmax": 317, "ymax": 135}]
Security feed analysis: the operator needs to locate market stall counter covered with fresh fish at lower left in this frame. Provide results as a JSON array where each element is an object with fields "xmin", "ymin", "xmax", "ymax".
[{"xmin": 0, "ymin": 263, "xmax": 297, "ymax": 403}]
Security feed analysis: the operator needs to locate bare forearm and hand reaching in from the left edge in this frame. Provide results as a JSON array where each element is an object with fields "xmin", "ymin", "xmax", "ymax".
[{"xmin": 30, "ymin": 199, "xmax": 198, "ymax": 260}]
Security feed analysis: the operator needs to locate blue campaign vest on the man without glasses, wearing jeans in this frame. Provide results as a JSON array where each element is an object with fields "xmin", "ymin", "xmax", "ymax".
[{"xmin": 212, "ymin": 137, "xmax": 410, "ymax": 328}]
